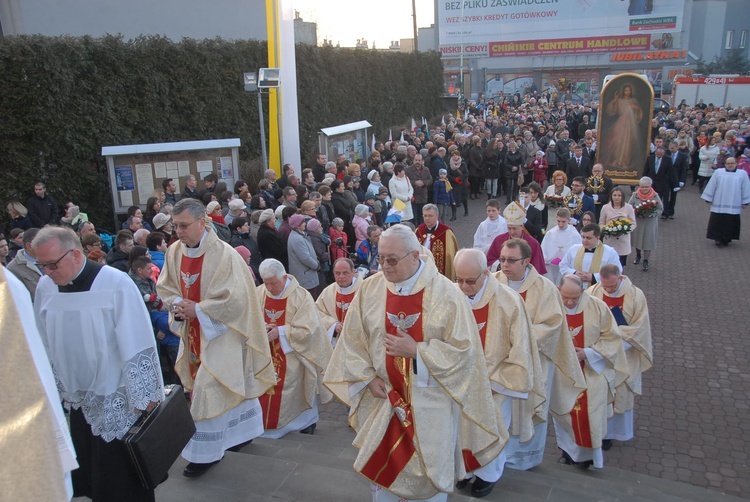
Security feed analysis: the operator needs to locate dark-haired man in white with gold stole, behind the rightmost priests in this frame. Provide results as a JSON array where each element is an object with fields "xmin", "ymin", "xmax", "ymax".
[{"xmin": 560, "ymin": 223, "xmax": 622, "ymax": 288}]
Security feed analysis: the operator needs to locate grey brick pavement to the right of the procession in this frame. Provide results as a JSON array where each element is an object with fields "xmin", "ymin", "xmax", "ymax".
[{"xmin": 320, "ymin": 186, "xmax": 750, "ymax": 498}]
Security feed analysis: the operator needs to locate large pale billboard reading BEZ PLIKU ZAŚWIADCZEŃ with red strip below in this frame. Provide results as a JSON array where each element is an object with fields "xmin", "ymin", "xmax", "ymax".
[{"xmin": 438, "ymin": 0, "xmax": 685, "ymax": 57}]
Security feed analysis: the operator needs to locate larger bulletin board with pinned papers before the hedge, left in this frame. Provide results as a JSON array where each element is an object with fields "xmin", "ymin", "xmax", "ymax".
[{"xmin": 102, "ymin": 138, "xmax": 240, "ymax": 220}]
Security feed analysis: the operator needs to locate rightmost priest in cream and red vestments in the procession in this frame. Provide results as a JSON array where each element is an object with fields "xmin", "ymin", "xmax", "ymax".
[{"xmin": 589, "ymin": 265, "xmax": 653, "ymax": 450}]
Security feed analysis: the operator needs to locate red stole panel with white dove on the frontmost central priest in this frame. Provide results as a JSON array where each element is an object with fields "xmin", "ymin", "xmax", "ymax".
[{"xmin": 361, "ymin": 290, "xmax": 424, "ymax": 488}]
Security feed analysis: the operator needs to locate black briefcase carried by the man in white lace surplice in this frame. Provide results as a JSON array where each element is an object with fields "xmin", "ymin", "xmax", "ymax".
[{"xmin": 122, "ymin": 385, "xmax": 195, "ymax": 490}]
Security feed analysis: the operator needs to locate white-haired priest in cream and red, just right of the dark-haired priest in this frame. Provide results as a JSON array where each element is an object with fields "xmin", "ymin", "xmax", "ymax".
[{"xmin": 258, "ymin": 258, "xmax": 332, "ymax": 439}]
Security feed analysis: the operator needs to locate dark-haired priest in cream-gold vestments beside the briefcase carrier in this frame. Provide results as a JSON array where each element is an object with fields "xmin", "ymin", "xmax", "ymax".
[{"xmin": 157, "ymin": 199, "xmax": 276, "ymax": 478}]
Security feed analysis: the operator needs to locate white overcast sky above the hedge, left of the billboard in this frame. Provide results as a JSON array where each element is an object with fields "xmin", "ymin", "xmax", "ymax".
[{"xmin": 294, "ymin": 0, "xmax": 435, "ymax": 49}]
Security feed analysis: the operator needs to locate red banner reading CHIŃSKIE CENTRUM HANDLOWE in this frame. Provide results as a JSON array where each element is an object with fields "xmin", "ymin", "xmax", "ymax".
[{"xmin": 490, "ymin": 35, "xmax": 651, "ymax": 57}]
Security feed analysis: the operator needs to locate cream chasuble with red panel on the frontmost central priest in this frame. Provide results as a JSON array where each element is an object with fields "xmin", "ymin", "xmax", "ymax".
[{"xmin": 324, "ymin": 262, "xmax": 507, "ymax": 499}]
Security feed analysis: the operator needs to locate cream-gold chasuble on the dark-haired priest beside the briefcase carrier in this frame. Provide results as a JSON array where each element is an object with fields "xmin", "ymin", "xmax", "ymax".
[{"xmin": 157, "ymin": 230, "xmax": 276, "ymax": 421}]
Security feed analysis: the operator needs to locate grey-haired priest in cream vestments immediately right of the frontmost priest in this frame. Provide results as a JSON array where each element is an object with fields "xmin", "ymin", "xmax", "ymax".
[{"xmin": 455, "ymin": 249, "xmax": 545, "ymax": 497}]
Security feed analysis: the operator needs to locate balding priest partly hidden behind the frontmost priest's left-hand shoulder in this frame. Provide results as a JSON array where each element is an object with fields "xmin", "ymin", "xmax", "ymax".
[{"xmin": 315, "ymin": 256, "xmax": 366, "ymax": 347}]
